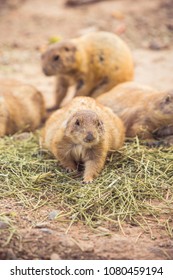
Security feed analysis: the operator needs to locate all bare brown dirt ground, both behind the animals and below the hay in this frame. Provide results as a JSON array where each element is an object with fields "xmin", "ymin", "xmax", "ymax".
[{"xmin": 0, "ymin": 0, "xmax": 173, "ymax": 260}]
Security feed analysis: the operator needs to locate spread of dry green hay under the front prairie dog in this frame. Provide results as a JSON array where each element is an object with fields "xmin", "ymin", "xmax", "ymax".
[{"xmin": 0, "ymin": 132, "xmax": 173, "ymax": 236}]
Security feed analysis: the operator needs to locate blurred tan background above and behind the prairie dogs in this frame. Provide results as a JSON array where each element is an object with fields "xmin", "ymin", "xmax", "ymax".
[{"xmin": 0, "ymin": 0, "xmax": 173, "ymax": 106}]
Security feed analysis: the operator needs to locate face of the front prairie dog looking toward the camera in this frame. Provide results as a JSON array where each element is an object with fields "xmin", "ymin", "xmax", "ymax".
[{"xmin": 65, "ymin": 110, "xmax": 104, "ymax": 148}]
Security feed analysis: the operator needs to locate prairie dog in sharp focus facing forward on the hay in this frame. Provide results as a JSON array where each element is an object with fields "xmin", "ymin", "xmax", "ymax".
[{"xmin": 41, "ymin": 97, "xmax": 124, "ymax": 183}]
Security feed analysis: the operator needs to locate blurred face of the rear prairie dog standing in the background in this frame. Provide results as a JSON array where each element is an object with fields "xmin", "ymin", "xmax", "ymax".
[{"xmin": 41, "ymin": 42, "xmax": 77, "ymax": 76}]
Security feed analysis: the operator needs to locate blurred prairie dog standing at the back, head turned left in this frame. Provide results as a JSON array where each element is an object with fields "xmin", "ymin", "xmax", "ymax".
[{"xmin": 42, "ymin": 32, "xmax": 134, "ymax": 107}]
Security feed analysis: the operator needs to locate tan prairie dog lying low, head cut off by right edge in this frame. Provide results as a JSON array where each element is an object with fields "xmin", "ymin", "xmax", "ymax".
[{"xmin": 97, "ymin": 82, "xmax": 173, "ymax": 139}]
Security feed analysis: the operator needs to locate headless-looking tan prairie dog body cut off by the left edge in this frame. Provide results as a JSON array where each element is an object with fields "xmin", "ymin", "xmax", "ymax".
[{"xmin": 0, "ymin": 79, "xmax": 45, "ymax": 137}]
